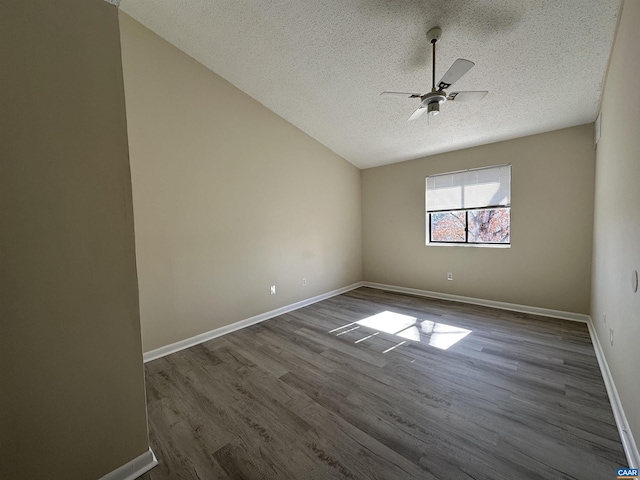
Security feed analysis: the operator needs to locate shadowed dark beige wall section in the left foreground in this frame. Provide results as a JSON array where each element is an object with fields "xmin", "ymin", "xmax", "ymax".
[{"xmin": 0, "ymin": 0, "xmax": 148, "ymax": 480}]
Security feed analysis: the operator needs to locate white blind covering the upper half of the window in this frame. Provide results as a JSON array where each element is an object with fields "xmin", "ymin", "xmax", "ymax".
[{"xmin": 426, "ymin": 165, "xmax": 511, "ymax": 212}]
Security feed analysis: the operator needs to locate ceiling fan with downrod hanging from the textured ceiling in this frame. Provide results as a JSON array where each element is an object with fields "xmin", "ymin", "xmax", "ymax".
[{"xmin": 380, "ymin": 27, "xmax": 489, "ymax": 121}]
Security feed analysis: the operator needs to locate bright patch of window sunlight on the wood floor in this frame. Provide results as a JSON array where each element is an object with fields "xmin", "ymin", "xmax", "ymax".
[{"xmin": 329, "ymin": 310, "xmax": 471, "ymax": 353}]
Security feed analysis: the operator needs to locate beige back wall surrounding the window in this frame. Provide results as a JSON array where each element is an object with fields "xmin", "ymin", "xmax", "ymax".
[{"xmin": 362, "ymin": 125, "xmax": 595, "ymax": 313}]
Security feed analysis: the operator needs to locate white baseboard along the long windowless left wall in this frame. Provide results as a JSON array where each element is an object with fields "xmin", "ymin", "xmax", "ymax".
[{"xmin": 143, "ymin": 282, "xmax": 362, "ymax": 363}]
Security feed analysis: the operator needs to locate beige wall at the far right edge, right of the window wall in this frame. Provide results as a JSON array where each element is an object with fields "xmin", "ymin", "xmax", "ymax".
[{"xmin": 591, "ymin": 0, "xmax": 640, "ymax": 458}]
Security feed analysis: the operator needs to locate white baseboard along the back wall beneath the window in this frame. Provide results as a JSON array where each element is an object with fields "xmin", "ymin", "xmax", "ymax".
[{"xmin": 362, "ymin": 282, "xmax": 589, "ymax": 323}]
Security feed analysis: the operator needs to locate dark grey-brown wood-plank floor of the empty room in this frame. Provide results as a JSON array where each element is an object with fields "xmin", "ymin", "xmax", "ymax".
[{"xmin": 141, "ymin": 288, "xmax": 627, "ymax": 480}]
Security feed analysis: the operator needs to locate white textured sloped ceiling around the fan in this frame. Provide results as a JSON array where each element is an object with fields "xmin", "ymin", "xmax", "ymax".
[{"xmin": 120, "ymin": 0, "xmax": 620, "ymax": 168}]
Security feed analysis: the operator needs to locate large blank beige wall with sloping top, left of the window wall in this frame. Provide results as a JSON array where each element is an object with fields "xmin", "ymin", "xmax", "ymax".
[{"xmin": 120, "ymin": 14, "xmax": 362, "ymax": 351}]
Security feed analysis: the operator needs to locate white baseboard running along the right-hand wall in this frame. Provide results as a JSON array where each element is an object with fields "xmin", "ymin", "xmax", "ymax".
[{"xmin": 587, "ymin": 317, "xmax": 640, "ymax": 468}]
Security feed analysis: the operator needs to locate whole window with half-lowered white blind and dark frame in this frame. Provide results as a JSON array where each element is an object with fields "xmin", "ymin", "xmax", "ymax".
[{"xmin": 425, "ymin": 165, "xmax": 511, "ymax": 245}]
